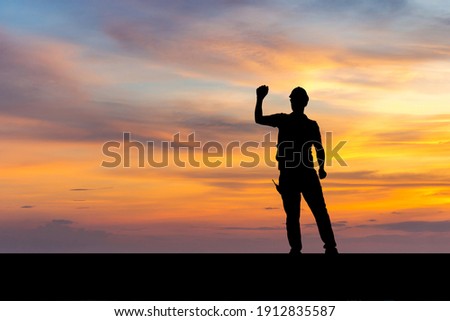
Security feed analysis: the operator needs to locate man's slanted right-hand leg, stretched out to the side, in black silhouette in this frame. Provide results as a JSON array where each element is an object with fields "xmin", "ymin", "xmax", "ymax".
[{"xmin": 302, "ymin": 171, "xmax": 336, "ymax": 253}]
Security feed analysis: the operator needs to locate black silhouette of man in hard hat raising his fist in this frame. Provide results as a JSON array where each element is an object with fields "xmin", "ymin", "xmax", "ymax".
[{"xmin": 255, "ymin": 85, "xmax": 338, "ymax": 254}]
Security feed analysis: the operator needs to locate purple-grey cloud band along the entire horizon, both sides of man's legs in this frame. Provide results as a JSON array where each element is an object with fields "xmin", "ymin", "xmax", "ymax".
[{"xmin": 0, "ymin": 219, "xmax": 450, "ymax": 253}]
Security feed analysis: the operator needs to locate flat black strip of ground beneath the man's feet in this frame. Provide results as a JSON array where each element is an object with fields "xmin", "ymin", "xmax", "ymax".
[{"xmin": 0, "ymin": 254, "xmax": 450, "ymax": 301}]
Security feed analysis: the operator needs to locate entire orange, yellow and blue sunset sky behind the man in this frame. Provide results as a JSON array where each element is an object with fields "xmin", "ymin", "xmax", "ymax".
[{"xmin": 0, "ymin": 0, "xmax": 450, "ymax": 253}]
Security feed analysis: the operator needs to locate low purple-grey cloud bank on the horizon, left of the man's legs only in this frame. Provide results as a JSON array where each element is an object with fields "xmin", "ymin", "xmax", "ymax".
[{"xmin": 0, "ymin": 219, "xmax": 284, "ymax": 253}]
